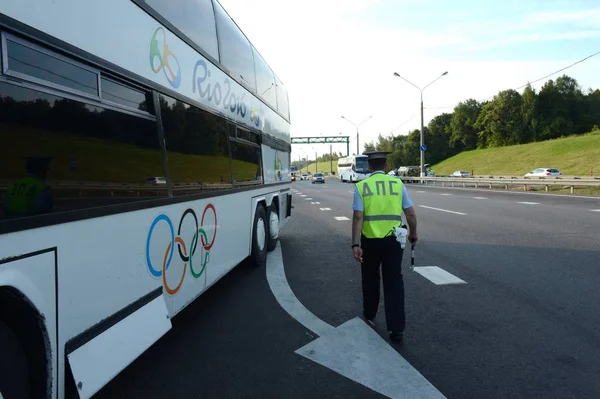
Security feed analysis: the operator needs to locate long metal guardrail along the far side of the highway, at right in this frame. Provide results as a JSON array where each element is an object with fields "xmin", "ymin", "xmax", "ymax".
[{"xmin": 400, "ymin": 176, "xmax": 600, "ymax": 193}]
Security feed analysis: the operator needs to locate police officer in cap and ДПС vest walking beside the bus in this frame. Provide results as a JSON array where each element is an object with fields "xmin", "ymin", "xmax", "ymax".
[{"xmin": 352, "ymin": 151, "xmax": 418, "ymax": 342}]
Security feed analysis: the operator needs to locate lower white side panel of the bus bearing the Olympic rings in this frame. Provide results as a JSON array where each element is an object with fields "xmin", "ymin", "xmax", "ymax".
[{"xmin": 0, "ymin": 186, "xmax": 289, "ymax": 396}]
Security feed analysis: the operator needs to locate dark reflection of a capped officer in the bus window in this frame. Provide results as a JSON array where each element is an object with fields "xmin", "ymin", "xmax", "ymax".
[{"xmin": 4, "ymin": 157, "xmax": 53, "ymax": 218}]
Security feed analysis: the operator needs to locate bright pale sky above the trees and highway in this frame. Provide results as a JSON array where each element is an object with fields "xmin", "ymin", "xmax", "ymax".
[{"xmin": 219, "ymin": 0, "xmax": 600, "ymax": 160}]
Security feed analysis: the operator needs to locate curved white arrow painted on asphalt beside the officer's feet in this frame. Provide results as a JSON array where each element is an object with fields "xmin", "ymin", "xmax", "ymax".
[{"xmin": 267, "ymin": 243, "xmax": 445, "ymax": 399}]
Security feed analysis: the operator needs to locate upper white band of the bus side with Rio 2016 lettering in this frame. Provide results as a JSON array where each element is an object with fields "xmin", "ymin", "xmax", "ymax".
[{"xmin": 0, "ymin": 0, "xmax": 290, "ymax": 142}]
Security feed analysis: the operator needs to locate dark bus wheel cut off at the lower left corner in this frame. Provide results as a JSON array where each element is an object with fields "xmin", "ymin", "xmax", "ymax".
[{"xmin": 0, "ymin": 320, "xmax": 31, "ymax": 399}]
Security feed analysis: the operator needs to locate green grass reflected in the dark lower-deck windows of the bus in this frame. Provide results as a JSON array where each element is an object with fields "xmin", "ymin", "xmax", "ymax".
[{"xmin": 0, "ymin": 126, "xmax": 256, "ymax": 184}]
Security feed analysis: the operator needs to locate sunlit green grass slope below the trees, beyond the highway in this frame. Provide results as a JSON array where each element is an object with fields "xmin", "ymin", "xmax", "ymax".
[{"xmin": 432, "ymin": 131, "xmax": 600, "ymax": 176}]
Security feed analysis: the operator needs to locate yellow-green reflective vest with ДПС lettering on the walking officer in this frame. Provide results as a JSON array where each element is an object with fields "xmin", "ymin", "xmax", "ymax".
[{"xmin": 356, "ymin": 172, "xmax": 402, "ymax": 238}]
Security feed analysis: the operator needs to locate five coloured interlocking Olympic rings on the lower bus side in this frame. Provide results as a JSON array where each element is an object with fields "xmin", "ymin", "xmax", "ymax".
[{"xmin": 146, "ymin": 204, "xmax": 217, "ymax": 295}]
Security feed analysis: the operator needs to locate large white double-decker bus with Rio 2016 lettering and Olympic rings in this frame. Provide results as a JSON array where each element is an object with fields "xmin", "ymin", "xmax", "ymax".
[{"xmin": 0, "ymin": 0, "xmax": 291, "ymax": 399}]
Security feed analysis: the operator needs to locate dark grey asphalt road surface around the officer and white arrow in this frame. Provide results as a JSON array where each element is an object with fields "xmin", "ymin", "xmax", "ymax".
[{"xmin": 96, "ymin": 181, "xmax": 600, "ymax": 398}]
